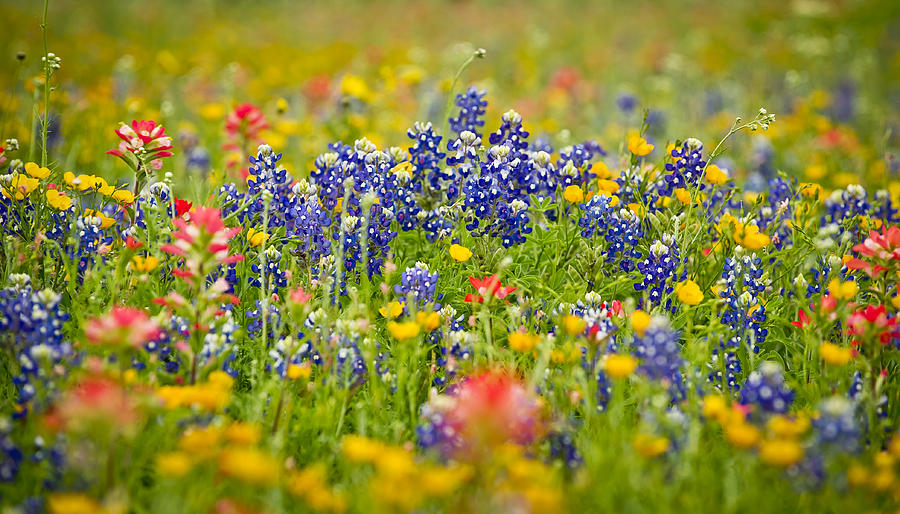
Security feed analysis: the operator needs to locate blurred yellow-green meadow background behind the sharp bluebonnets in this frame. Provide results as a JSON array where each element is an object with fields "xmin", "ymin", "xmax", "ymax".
[{"xmin": 0, "ymin": 0, "xmax": 900, "ymax": 188}]
